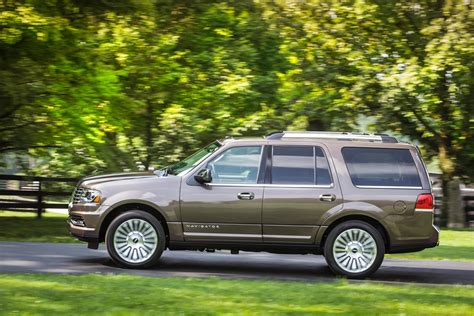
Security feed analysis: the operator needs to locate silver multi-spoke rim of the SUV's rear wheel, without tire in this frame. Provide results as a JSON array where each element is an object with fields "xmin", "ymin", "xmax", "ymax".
[{"xmin": 332, "ymin": 228, "xmax": 377, "ymax": 273}]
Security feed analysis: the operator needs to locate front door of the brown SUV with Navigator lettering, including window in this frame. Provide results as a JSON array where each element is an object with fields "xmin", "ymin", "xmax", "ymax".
[{"xmin": 181, "ymin": 146, "xmax": 263, "ymax": 242}]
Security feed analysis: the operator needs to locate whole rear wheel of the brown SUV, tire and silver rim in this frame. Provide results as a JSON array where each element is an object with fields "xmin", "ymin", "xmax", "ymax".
[{"xmin": 324, "ymin": 220, "xmax": 385, "ymax": 278}]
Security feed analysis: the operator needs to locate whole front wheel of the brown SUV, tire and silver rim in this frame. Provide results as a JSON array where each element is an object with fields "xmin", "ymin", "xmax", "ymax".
[{"xmin": 105, "ymin": 210, "xmax": 166, "ymax": 268}]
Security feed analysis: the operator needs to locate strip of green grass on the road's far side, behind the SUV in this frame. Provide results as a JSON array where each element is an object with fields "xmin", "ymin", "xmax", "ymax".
[{"xmin": 0, "ymin": 211, "xmax": 474, "ymax": 261}]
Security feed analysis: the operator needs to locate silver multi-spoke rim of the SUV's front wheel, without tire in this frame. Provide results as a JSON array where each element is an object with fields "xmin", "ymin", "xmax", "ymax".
[{"xmin": 113, "ymin": 219, "xmax": 158, "ymax": 263}]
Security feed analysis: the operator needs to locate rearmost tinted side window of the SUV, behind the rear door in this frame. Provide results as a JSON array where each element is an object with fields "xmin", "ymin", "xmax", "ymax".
[{"xmin": 342, "ymin": 147, "xmax": 421, "ymax": 187}]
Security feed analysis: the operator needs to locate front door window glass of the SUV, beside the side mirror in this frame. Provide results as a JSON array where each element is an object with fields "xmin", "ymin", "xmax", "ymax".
[{"xmin": 207, "ymin": 146, "xmax": 262, "ymax": 184}]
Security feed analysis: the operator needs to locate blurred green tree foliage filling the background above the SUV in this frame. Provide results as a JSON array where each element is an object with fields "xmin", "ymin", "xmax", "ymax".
[{"xmin": 0, "ymin": 0, "xmax": 474, "ymax": 180}]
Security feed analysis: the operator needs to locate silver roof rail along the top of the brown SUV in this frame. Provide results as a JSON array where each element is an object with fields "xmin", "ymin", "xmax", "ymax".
[{"xmin": 266, "ymin": 131, "xmax": 398, "ymax": 143}]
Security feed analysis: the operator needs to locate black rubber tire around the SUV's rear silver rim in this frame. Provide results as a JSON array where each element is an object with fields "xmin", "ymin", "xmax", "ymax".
[{"xmin": 324, "ymin": 220, "xmax": 385, "ymax": 279}]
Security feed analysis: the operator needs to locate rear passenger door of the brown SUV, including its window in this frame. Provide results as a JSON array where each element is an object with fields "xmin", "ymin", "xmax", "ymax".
[{"xmin": 262, "ymin": 146, "xmax": 342, "ymax": 244}]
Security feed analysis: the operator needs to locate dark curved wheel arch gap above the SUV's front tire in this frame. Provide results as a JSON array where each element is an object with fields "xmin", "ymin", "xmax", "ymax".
[{"xmin": 99, "ymin": 202, "xmax": 170, "ymax": 245}]
